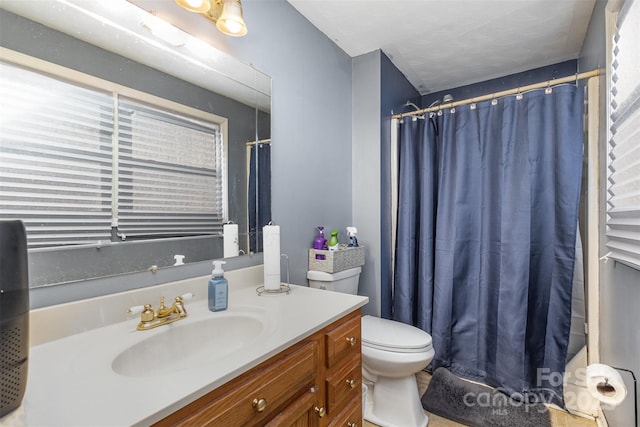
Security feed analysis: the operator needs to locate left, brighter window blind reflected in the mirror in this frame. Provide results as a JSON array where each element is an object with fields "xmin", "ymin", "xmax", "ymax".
[{"xmin": 0, "ymin": 63, "xmax": 113, "ymax": 247}]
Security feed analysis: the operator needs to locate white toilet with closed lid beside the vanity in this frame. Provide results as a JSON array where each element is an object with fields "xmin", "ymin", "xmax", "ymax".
[{"xmin": 307, "ymin": 267, "xmax": 434, "ymax": 427}]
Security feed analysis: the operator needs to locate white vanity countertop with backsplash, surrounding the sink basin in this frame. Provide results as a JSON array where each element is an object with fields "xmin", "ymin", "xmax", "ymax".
[{"xmin": 0, "ymin": 270, "xmax": 368, "ymax": 427}]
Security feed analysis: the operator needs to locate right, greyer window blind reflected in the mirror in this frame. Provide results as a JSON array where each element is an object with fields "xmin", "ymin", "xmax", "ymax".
[{"xmin": 117, "ymin": 99, "xmax": 224, "ymax": 237}]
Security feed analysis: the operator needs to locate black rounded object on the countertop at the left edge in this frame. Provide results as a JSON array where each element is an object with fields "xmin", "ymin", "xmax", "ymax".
[{"xmin": 0, "ymin": 221, "xmax": 29, "ymax": 417}]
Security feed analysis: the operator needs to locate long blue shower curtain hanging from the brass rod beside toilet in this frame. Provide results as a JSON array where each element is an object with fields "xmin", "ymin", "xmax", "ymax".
[{"xmin": 393, "ymin": 85, "xmax": 583, "ymax": 405}]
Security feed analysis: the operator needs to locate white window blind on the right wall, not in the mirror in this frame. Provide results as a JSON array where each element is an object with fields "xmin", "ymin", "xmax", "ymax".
[{"xmin": 606, "ymin": 0, "xmax": 640, "ymax": 269}]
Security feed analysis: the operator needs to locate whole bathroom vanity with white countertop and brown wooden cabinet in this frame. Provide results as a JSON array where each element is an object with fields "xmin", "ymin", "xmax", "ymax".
[{"xmin": 0, "ymin": 266, "xmax": 368, "ymax": 426}]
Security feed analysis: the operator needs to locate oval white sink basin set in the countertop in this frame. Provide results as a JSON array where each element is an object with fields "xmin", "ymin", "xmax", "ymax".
[{"xmin": 111, "ymin": 314, "xmax": 265, "ymax": 377}]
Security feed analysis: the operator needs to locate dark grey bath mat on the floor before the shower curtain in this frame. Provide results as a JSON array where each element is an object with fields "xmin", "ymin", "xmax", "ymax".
[{"xmin": 422, "ymin": 368, "xmax": 551, "ymax": 427}]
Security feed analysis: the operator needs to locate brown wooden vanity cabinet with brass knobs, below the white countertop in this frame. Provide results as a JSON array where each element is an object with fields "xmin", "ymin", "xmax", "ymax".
[{"xmin": 154, "ymin": 309, "xmax": 362, "ymax": 427}]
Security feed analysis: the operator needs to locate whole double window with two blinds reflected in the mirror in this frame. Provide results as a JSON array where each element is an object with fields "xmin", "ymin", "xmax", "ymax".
[{"xmin": 0, "ymin": 59, "xmax": 225, "ymax": 248}]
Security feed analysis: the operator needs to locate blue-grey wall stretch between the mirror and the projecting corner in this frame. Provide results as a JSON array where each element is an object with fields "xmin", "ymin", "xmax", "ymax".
[{"xmin": 212, "ymin": 0, "xmax": 352, "ymax": 284}]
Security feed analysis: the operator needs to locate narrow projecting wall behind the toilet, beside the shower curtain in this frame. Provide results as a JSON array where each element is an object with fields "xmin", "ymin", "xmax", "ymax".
[{"xmin": 352, "ymin": 50, "xmax": 419, "ymax": 318}]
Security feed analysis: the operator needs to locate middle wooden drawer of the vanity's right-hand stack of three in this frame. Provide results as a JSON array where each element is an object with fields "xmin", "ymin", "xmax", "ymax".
[{"xmin": 326, "ymin": 354, "xmax": 362, "ymax": 416}]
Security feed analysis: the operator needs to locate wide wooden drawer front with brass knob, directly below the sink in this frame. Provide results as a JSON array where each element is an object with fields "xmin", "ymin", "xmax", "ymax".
[{"xmin": 178, "ymin": 341, "xmax": 318, "ymax": 426}]
